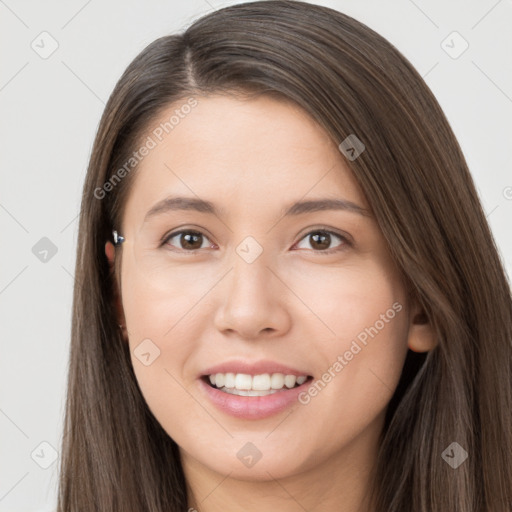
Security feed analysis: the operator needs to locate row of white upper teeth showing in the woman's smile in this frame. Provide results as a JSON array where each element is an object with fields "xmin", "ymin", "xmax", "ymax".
[{"xmin": 208, "ymin": 373, "xmax": 307, "ymax": 396}]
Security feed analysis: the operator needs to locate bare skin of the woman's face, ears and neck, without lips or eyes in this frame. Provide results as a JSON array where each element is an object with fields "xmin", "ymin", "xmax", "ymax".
[{"xmin": 105, "ymin": 95, "xmax": 435, "ymax": 512}]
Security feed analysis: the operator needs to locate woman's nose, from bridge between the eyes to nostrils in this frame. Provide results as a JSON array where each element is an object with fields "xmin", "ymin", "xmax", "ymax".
[{"xmin": 214, "ymin": 254, "xmax": 291, "ymax": 340}]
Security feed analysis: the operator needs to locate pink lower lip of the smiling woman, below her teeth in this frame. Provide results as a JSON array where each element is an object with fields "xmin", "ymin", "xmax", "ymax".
[{"xmin": 199, "ymin": 377, "xmax": 312, "ymax": 420}]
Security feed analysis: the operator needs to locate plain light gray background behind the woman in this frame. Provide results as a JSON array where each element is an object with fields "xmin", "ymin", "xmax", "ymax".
[{"xmin": 0, "ymin": 0, "xmax": 512, "ymax": 512}]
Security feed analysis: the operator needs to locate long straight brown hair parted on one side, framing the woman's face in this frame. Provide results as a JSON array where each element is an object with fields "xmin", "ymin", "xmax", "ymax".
[{"xmin": 58, "ymin": 0, "xmax": 512, "ymax": 512}]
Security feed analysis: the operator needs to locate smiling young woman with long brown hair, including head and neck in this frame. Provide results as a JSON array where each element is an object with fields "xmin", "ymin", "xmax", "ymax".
[{"xmin": 59, "ymin": 1, "xmax": 512, "ymax": 512}]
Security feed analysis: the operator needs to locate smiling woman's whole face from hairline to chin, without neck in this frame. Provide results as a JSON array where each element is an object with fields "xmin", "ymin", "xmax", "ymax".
[{"xmin": 117, "ymin": 95, "xmax": 422, "ymax": 480}]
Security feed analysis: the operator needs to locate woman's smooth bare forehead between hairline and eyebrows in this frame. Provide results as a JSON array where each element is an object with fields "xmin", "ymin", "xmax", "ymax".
[{"xmin": 125, "ymin": 95, "xmax": 365, "ymax": 226}]
